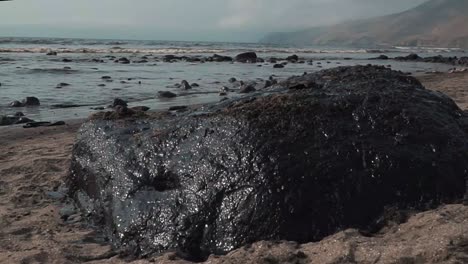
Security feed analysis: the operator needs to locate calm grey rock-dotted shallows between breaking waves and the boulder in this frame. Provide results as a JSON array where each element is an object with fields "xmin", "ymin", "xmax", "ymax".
[{"xmin": 0, "ymin": 48, "xmax": 467, "ymax": 124}]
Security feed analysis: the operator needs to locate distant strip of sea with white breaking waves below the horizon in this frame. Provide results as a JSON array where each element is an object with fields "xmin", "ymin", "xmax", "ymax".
[{"xmin": 0, "ymin": 38, "xmax": 463, "ymax": 54}]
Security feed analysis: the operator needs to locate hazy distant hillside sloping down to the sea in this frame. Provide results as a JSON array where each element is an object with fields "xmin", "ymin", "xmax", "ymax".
[{"xmin": 261, "ymin": 0, "xmax": 468, "ymax": 48}]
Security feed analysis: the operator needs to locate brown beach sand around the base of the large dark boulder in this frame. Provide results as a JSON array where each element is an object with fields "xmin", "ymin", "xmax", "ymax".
[{"xmin": 0, "ymin": 73, "xmax": 468, "ymax": 263}]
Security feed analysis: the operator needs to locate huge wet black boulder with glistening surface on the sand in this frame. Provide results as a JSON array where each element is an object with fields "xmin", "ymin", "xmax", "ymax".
[{"xmin": 68, "ymin": 66, "xmax": 468, "ymax": 260}]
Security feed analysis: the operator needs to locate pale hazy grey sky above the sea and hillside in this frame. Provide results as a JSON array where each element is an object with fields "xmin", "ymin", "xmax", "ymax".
[{"xmin": 0, "ymin": 0, "xmax": 426, "ymax": 41}]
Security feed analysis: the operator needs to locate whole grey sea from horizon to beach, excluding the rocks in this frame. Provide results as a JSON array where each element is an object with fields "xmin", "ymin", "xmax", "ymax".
[{"xmin": 0, "ymin": 38, "xmax": 466, "ymax": 121}]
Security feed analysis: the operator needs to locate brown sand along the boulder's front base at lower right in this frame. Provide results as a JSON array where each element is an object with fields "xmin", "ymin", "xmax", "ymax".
[{"xmin": 158, "ymin": 205, "xmax": 468, "ymax": 264}]
